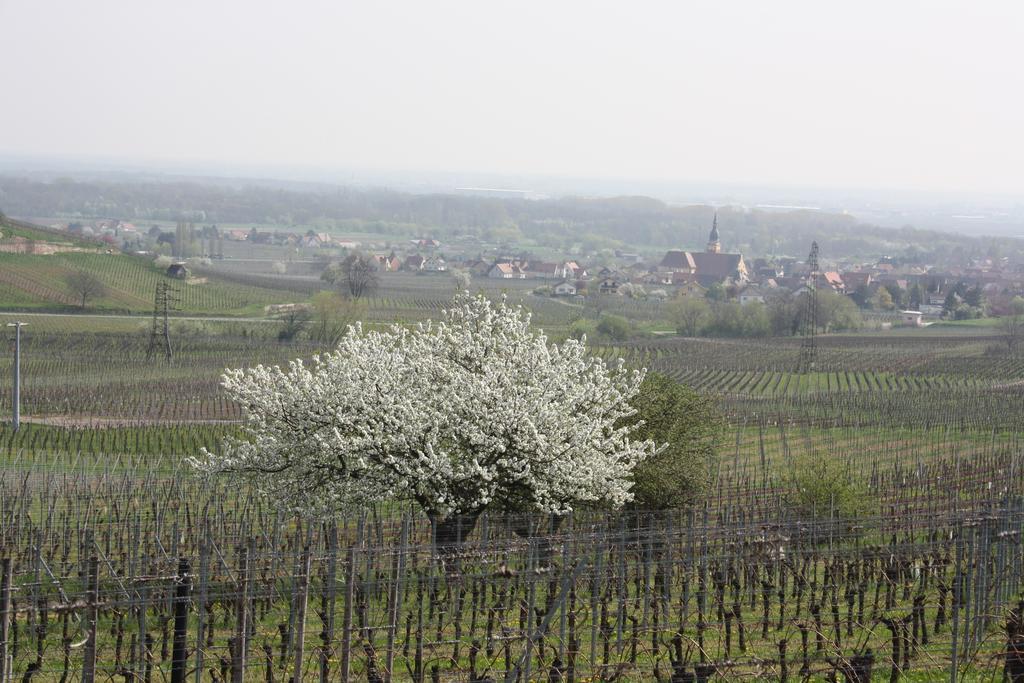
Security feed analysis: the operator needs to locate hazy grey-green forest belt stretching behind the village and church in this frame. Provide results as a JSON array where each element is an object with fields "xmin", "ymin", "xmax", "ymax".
[{"xmin": 0, "ymin": 176, "xmax": 1024, "ymax": 263}]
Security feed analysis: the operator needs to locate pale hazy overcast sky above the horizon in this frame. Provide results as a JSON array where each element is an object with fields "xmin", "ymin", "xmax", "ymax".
[{"xmin": 0, "ymin": 0, "xmax": 1024, "ymax": 194}]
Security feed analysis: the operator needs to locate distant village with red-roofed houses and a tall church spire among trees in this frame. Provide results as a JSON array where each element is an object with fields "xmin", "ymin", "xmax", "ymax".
[{"xmin": 53, "ymin": 215, "xmax": 1024, "ymax": 325}]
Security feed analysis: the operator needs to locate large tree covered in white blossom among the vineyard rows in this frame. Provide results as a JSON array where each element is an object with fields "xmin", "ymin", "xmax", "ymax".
[{"xmin": 194, "ymin": 294, "xmax": 655, "ymax": 545}]
